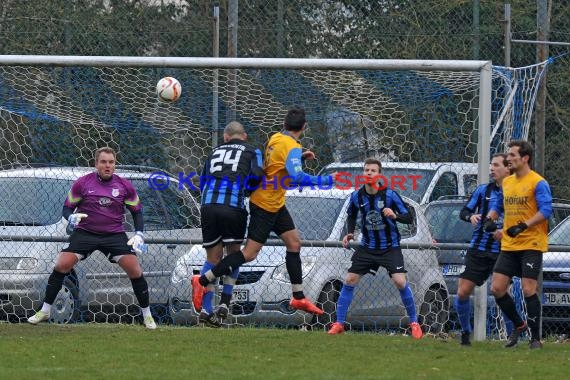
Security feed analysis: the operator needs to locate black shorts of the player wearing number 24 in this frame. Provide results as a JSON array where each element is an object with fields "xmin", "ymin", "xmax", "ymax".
[{"xmin": 200, "ymin": 205, "xmax": 247, "ymax": 248}]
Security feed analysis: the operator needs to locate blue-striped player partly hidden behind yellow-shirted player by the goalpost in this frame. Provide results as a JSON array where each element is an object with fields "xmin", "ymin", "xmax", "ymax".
[{"xmin": 455, "ymin": 153, "xmax": 510, "ymax": 346}]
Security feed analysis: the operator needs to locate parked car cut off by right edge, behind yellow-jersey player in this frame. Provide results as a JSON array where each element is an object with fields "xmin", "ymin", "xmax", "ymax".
[{"xmin": 542, "ymin": 217, "xmax": 570, "ymax": 334}]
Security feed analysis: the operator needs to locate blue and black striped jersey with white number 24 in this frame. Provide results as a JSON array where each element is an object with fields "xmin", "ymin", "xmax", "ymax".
[{"xmin": 200, "ymin": 139, "xmax": 263, "ymax": 208}]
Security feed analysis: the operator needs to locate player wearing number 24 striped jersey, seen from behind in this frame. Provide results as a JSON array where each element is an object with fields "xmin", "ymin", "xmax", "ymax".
[{"xmin": 192, "ymin": 121, "xmax": 263, "ymax": 327}]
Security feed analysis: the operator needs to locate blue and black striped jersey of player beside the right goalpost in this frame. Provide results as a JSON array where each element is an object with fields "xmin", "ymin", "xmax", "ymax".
[{"xmin": 462, "ymin": 182, "xmax": 503, "ymax": 253}]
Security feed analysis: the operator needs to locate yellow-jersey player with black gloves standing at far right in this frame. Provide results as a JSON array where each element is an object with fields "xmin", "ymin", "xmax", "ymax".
[{"xmin": 485, "ymin": 140, "xmax": 552, "ymax": 349}]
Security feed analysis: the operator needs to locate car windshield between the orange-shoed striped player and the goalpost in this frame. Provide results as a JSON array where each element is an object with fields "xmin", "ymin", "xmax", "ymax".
[{"xmin": 425, "ymin": 203, "xmax": 473, "ymax": 243}]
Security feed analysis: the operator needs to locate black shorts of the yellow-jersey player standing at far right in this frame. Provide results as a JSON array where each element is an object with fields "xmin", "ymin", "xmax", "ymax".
[{"xmin": 493, "ymin": 250, "xmax": 543, "ymax": 280}]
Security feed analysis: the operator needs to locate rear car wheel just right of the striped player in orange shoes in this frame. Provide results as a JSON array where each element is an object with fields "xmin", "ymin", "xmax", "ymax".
[{"xmin": 418, "ymin": 285, "xmax": 449, "ymax": 335}]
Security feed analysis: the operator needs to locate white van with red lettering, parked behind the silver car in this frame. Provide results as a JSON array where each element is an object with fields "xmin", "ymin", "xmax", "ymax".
[{"xmin": 319, "ymin": 162, "xmax": 478, "ymax": 205}]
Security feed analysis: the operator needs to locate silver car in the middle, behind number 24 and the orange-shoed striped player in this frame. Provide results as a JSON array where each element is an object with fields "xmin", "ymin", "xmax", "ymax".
[{"xmin": 169, "ymin": 189, "xmax": 449, "ymax": 332}]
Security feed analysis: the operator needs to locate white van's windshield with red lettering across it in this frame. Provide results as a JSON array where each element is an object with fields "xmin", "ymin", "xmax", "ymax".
[{"xmin": 318, "ymin": 167, "xmax": 435, "ymax": 203}]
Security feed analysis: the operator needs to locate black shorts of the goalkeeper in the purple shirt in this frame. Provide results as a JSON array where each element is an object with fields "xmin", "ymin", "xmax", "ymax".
[{"xmin": 61, "ymin": 229, "xmax": 136, "ymax": 263}]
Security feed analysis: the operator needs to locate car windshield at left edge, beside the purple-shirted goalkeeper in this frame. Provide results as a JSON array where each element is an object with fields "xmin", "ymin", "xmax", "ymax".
[{"xmin": 0, "ymin": 177, "xmax": 72, "ymax": 226}]
